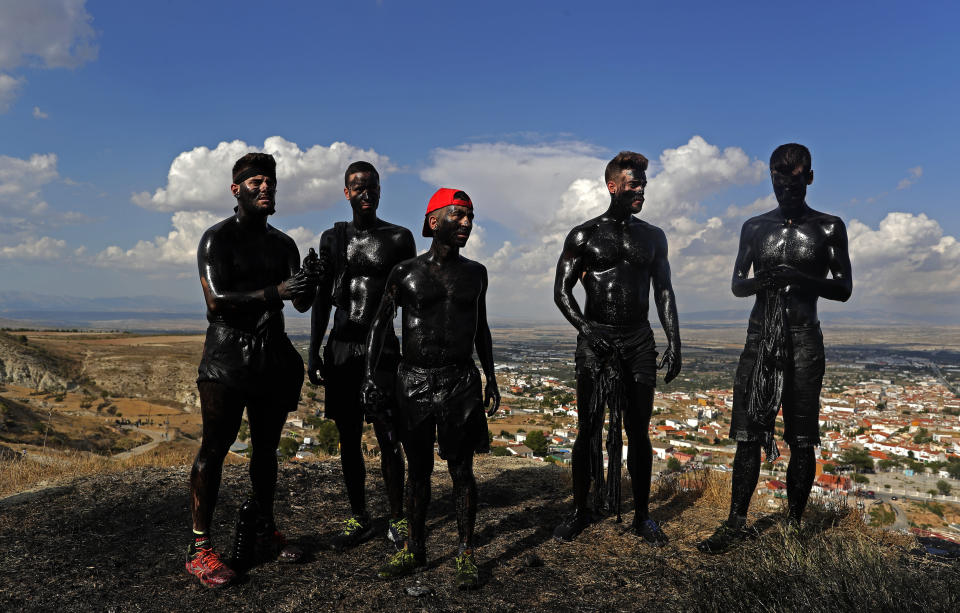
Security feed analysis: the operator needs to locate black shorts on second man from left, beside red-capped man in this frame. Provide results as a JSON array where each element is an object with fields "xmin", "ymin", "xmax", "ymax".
[{"xmin": 323, "ymin": 333, "xmax": 400, "ymax": 421}]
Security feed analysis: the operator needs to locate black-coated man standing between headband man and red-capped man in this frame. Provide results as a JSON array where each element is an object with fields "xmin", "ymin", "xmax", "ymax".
[{"xmin": 307, "ymin": 161, "xmax": 417, "ymax": 551}]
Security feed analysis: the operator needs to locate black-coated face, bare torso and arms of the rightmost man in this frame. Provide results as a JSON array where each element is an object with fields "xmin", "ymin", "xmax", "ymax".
[{"xmin": 731, "ymin": 161, "xmax": 853, "ymax": 326}]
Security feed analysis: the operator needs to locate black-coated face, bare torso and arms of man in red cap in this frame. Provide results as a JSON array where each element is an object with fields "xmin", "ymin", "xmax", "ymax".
[{"xmin": 364, "ymin": 205, "xmax": 500, "ymax": 415}]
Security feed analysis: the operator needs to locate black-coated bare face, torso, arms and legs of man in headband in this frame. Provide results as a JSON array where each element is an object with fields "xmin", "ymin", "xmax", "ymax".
[{"xmin": 190, "ymin": 175, "xmax": 319, "ymax": 532}]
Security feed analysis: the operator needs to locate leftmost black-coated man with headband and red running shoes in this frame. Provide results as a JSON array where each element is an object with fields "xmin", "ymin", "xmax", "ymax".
[{"xmin": 186, "ymin": 153, "xmax": 319, "ymax": 587}]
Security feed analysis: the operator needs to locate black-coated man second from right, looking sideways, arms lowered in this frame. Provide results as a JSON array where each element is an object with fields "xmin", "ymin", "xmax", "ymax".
[{"xmin": 553, "ymin": 151, "xmax": 681, "ymax": 546}]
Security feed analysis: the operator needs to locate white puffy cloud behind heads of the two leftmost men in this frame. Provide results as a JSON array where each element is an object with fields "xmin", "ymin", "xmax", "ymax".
[{"xmin": 131, "ymin": 136, "xmax": 396, "ymax": 213}]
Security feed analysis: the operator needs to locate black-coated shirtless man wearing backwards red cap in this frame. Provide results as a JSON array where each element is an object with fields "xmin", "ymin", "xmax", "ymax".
[{"xmin": 363, "ymin": 188, "xmax": 500, "ymax": 589}]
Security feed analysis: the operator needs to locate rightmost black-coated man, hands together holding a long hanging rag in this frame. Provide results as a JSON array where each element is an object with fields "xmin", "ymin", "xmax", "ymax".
[{"xmin": 698, "ymin": 143, "xmax": 853, "ymax": 553}]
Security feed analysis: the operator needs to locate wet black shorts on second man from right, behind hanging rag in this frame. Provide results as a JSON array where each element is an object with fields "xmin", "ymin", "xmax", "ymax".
[{"xmin": 574, "ymin": 324, "xmax": 657, "ymax": 387}]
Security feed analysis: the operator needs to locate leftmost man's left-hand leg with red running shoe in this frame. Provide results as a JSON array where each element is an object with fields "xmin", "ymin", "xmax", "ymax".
[{"xmin": 186, "ymin": 381, "xmax": 243, "ymax": 587}]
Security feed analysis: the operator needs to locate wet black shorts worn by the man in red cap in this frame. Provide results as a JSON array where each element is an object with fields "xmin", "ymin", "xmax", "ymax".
[{"xmin": 397, "ymin": 360, "xmax": 490, "ymax": 460}]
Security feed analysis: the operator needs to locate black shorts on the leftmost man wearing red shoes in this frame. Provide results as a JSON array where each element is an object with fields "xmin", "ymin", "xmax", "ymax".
[{"xmin": 197, "ymin": 313, "xmax": 304, "ymax": 412}]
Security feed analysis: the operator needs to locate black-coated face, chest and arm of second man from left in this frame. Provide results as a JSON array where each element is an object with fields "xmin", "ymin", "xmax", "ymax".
[{"xmin": 307, "ymin": 172, "xmax": 417, "ymax": 385}]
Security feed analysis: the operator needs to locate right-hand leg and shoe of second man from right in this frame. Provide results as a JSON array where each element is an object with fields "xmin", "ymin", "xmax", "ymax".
[{"xmin": 623, "ymin": 380, "xmax": 669, "ymax": 547}]
